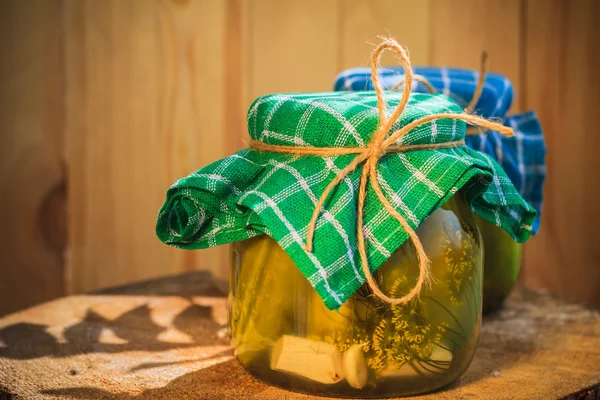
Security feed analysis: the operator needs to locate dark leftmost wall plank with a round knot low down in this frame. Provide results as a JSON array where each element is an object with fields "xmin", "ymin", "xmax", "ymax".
[{"xmin": 0, "ymin": 0, "xmax": 66, "ymax": 315}]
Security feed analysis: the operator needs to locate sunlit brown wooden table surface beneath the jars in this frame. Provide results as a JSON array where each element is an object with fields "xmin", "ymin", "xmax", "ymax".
[{"xmin": 0, "ymin": 272, "xmax": 600, "ymax": 400}]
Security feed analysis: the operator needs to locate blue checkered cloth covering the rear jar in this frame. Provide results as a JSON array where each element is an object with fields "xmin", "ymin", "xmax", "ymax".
[{"xmin": 335, "ymin": 67, "xmax": 546, "ymax": 233}]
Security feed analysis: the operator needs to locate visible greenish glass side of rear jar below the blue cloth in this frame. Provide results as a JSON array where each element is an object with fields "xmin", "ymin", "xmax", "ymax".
[{"xmin": 475, "ymin": 215, "xmax": 523, "ymax": 314}]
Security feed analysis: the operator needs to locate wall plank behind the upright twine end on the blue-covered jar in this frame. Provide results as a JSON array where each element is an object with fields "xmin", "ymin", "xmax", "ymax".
[{"xmin": 430, "ymin": 0, "xmax": 523, "ymax": 112}]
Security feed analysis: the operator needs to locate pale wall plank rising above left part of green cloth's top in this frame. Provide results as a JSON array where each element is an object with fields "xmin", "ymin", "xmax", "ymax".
[{"xmin": 248, "ymin": 0, "xmax": 340, "ymax": 100}]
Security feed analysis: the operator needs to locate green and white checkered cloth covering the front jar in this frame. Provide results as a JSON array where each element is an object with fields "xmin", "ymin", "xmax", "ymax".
[{"xmin": 156, "ymin": 92, "xmax": 535, "ymax": 309}]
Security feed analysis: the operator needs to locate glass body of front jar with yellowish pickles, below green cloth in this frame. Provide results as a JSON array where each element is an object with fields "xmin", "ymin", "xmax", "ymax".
[{"xmin": 229, "ymin": 193, "xmax": 483, "ymax": 398}]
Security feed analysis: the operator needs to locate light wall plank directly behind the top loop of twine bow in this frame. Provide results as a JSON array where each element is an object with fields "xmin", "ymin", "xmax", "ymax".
[{"xmin": 340, "ymin": 0, "xmax": 431, "ymax": 70}]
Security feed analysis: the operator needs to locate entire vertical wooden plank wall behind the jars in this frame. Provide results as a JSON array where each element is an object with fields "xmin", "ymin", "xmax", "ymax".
[{"xmin": 0, "ymin": 0, "xmax": 600, "ymax": 313}]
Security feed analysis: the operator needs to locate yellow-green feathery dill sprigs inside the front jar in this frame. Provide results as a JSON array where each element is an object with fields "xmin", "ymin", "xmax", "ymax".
[{"xmin": 318, "ymin": 223, "xmax": 478, "ymax": 376}]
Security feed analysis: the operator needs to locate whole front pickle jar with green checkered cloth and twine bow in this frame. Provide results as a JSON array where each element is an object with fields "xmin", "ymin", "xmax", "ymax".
[{"xmin": 157, "ymin": 39, "xmax": 536, "ymax": 398}]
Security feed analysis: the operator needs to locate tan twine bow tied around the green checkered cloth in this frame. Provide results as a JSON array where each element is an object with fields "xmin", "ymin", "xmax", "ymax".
[{"xmin": 250, "ymin": 38, "xmax": 513, "ymax": 304}]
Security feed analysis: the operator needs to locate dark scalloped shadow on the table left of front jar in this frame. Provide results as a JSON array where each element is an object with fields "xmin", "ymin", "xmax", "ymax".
[{"xmin": 0, "ymin": 304, "xmax": 227, "ymax": 360}]
